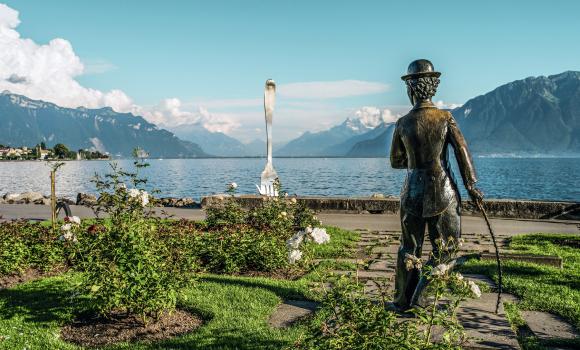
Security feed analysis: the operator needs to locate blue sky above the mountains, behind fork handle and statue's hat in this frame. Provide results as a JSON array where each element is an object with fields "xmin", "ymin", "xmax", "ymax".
[{"xmin": 0, "ymin": 0, "xmax": 580, "ymax": 141}]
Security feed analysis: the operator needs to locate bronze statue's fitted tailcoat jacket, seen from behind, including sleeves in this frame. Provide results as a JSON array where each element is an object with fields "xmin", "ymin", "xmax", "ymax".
[{"xmin": 391, "ymin": 102, "xmax": 477, "ymax": 217}]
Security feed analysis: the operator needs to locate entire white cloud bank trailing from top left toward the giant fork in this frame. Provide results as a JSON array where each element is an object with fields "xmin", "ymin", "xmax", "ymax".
[{"xmin": 0, "ymin": 4, "xmax": 233, "ymax": 132}]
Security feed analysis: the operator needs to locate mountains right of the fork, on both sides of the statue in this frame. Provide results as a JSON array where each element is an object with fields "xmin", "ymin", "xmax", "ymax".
[{"xmin": 276, "ymin": 71, "xmax": 580, "ymax": 157}]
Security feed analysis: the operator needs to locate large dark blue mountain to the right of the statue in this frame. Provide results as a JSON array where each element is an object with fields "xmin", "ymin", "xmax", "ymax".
[{"xmin": 452, "ymin": 71, "xmax": 580, "ymax": 154}]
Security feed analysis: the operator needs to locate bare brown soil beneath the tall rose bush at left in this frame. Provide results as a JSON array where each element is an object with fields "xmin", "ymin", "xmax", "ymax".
[{"xmin": 60, "ymin": 310, "xmax": 202, "ymax": 346}]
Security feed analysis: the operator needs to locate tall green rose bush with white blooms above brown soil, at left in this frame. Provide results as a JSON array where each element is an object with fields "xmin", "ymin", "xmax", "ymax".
[{"xmin": 72, "ymin": 161, "xmax": 195, "ymax": 322}]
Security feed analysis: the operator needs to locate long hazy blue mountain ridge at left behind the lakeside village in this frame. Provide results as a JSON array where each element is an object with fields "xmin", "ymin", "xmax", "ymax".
[{"xmin": 0, "ymin": 92, "xmax": 207, "ymax": 158}]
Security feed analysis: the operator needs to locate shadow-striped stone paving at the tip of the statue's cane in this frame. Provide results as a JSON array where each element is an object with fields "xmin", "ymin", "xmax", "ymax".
[{"xmin": 457, "ymin": 293, "xmax": 520, "ymax": 349}]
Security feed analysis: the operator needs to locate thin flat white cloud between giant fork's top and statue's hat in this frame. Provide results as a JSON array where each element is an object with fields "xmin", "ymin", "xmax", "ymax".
[{"xmin": 277, "ymin": 80, "xmax": 389, "ymax": 99}]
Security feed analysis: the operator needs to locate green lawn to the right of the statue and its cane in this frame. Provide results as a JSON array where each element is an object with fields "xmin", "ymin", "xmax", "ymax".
[{"xmin": 461, "ymin": 234, "xmax": 580, "ymax": 349}]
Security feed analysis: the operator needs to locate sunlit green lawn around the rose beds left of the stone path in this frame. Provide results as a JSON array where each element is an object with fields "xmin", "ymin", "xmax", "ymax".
[{"xmin": 0, "ymin": 228, "xmax": 359, "ymax": 349}]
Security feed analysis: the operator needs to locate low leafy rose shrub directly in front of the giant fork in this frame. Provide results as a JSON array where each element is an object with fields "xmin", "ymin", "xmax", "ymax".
[{"xmin": 198, "ymin": 180, "xmax": 320, "ymax": 273}]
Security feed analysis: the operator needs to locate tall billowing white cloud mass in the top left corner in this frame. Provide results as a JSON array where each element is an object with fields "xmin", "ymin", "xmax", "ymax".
[{"xmin": 0, "ymin": 4, "xmax": 134, "ymax": 112}]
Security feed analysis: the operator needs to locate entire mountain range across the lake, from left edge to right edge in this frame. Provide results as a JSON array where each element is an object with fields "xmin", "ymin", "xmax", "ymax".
[{"xmin": 0, "ymin": 71, "xmax": 580, "ymax": 158}]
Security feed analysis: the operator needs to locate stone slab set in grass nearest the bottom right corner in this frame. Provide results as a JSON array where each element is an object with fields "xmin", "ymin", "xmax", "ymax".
[{"xmin": 520, "ymin": 311, "xmax": 580, "ymax": 340}]
